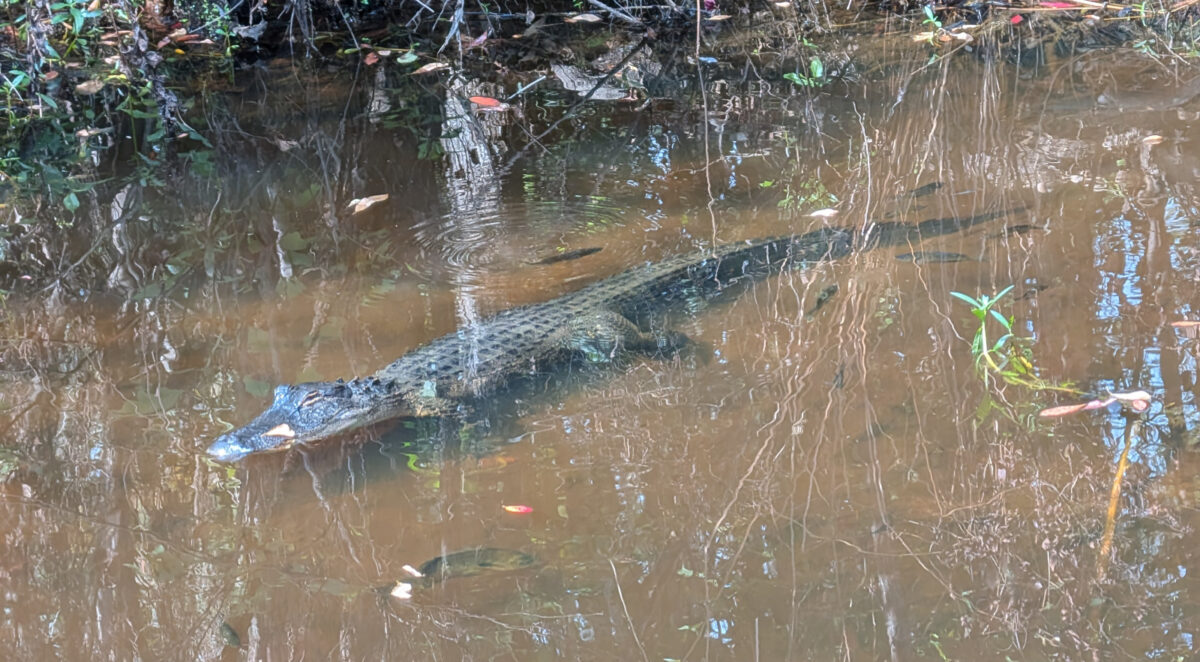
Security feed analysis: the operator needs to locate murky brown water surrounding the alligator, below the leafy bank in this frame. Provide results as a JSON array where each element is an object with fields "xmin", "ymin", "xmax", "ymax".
[{"xmin": 0, "ymin": 34, "xmax": 1200, "ymax": 661}]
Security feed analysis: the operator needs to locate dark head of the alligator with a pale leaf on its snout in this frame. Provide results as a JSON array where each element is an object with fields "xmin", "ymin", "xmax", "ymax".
[{"xmin": 208, "ymin": 378, "xmax": 403, "ymax": 462}]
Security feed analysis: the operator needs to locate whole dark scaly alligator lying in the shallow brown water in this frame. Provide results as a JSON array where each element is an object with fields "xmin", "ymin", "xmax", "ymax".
[{"xmin": 208, "ymin": 209, "xmax": 1021, "ymax": 462}]
